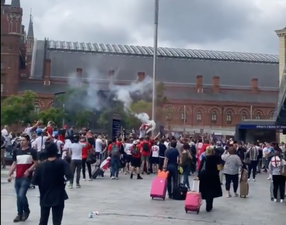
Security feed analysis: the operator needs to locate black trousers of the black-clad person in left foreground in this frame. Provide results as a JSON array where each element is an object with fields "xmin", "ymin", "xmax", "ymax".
[{"xmin": 39, "ymin": 203, "xmax": 65, "ymax": 225}]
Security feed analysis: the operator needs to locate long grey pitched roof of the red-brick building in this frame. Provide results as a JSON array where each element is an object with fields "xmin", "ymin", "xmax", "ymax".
[{"xmin": 31, "ymin": 41, "xmax": 279, "ymax": 89}]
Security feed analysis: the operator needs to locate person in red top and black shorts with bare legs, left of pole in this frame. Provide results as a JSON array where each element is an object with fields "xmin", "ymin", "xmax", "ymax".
[{"xmin": 130, "ymin": 141, "xmax": 143, "ymax": 180}]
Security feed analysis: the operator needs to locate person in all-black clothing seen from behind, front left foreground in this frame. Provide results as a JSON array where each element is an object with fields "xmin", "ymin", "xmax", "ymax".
[{"xmin": 32, "ymin": 142, "xmax": 72, "ymax": 225}]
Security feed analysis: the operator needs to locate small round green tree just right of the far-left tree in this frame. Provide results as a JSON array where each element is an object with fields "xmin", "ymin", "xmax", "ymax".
[{"xmin": 39, "ymin": 107, "xmax": 65, "ymax": 125}]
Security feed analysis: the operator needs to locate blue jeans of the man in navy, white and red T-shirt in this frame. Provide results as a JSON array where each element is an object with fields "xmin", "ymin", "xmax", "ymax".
[{"xmin": 15, "ymin": 178, "xmax": 31, "ymax": 215}]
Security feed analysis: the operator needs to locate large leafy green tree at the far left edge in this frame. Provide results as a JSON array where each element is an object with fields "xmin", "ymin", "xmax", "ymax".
[{"xmin": 1, "ymin": 91, "xmax": 36, "ymax": 125}]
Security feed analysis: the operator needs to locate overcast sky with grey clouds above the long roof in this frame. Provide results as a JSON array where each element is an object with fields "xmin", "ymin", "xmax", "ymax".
[{"xmin": 18, "ymin": 0, "xmax": 286, "ymax": 54}]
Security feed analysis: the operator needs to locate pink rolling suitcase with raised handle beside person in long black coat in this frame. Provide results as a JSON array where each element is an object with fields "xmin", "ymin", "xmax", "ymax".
[{"xmin": 185, "ymin": 181, "xmax": 202, "ymax": 214}]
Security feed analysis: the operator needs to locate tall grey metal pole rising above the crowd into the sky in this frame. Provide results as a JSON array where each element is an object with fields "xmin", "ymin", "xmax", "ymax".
[{"xmin": 152, "ymin": 0, "xmax": 159, "ymax": 136}]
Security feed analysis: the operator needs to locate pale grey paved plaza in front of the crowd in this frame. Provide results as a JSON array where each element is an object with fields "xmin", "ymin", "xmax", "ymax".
[{"xmin": 1, "ymin": 170, "xmax": 286, "ymax": 225}]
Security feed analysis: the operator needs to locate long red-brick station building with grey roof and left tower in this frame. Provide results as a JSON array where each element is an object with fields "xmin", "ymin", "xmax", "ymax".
[{"xmin": 1, "ymin": 0, "xmax": 279, "ymax": 132}]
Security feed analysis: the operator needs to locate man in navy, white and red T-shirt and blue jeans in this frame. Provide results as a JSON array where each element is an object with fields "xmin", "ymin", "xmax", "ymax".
[{"xmin": 8, "ymin": 134, "xmax": 37, "ymax": 223}]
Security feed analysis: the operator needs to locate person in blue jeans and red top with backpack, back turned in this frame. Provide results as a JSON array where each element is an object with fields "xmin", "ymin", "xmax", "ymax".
[{"xmin": 108, "ymin": 138, "xmax": 121, "ymax": 180}]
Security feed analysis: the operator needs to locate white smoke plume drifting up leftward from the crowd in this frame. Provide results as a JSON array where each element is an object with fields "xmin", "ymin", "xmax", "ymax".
[{"xmin": 68, "ymin": 71, "xmax": 156, "ymax": 133}]
